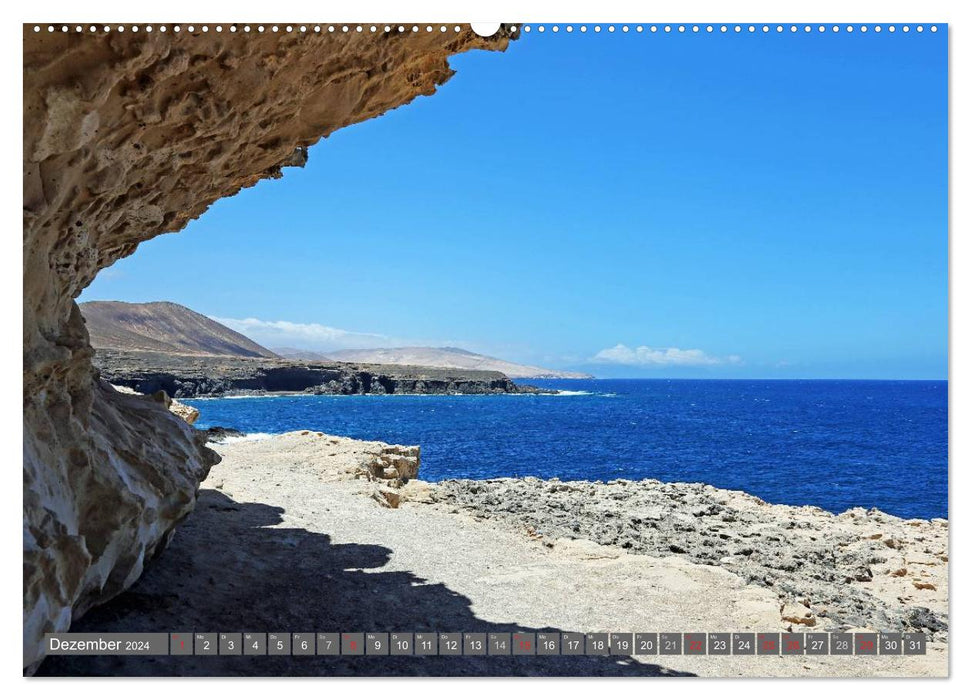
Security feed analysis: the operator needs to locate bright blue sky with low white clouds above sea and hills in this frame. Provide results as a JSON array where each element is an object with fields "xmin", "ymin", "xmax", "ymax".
[{"xmin": 81, "ymin": 27, "xmax": 948, "ymax": 378}]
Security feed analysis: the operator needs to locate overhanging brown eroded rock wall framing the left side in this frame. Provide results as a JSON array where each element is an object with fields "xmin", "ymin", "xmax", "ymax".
[{"xmin": 23, "ymin": 25, "xmax": 510, "ymax": 669}]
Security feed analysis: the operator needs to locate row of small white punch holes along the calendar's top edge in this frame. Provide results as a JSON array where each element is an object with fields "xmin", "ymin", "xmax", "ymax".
[{"xmin": 34, "ymin": 24, "xmax": 937, "ymax": 34}]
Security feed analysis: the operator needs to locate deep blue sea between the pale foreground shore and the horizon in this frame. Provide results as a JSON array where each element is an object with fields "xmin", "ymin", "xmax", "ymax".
[{"xmin": 186, "ymin": 379, "xmax": 948, "ymax": 518}]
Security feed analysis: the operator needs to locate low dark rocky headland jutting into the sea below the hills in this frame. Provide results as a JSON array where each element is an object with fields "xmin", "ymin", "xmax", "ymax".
[{"xmin": 94, "ymin": 350, "xmax": 556, "ymax": 399}]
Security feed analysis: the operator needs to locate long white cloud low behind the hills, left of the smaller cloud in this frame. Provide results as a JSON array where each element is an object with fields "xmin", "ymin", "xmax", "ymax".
[{"xmin": 212, "ymin": 316, "xmax": 393, "ymax": 352}]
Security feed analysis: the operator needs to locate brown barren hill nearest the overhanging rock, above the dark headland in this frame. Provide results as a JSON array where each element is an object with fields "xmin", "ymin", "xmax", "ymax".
[{"xmin": 80, "ymin": 301, "xmax": 277, "ymax": 357}]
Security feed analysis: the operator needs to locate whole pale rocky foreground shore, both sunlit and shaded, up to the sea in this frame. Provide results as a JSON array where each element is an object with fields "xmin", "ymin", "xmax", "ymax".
[{"xmin": 39, "ymin": 431, "xmax": 948, "ymax": 677}]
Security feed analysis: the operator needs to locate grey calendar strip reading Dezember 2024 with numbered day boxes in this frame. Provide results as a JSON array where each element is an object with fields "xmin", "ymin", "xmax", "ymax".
[{"xmin": 45, "ymin": 632, "xmax": 927, "ymax": 656}]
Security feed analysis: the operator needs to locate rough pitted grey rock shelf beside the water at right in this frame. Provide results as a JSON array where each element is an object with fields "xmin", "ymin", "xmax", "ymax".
[{"xmin": 429, "ymin": 477, "xmax": 948, "ymax": 641}]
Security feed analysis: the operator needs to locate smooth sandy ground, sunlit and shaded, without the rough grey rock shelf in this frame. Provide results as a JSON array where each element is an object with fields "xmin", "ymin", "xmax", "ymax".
[{"xmin": 39, "ymin": 432, "xmax": 948, "ymax": 677}]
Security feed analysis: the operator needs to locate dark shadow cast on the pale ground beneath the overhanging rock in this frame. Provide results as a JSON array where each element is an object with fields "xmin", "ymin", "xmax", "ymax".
[{"xmin": 37, "ymin": 490, "xmax": 690, "ymax": 676}]
